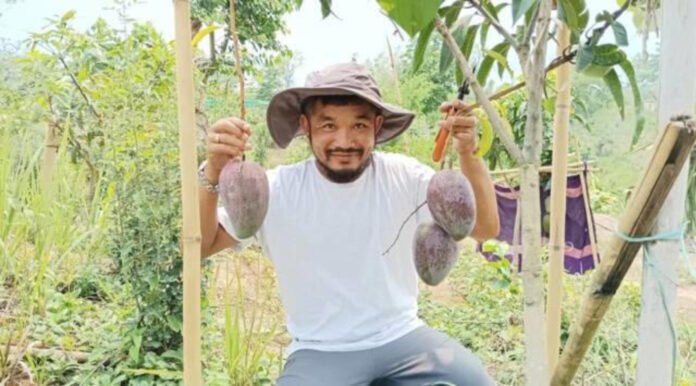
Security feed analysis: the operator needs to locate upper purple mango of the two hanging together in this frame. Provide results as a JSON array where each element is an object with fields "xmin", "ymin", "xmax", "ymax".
[{"xmin": 428, "ymin": 170, "xmax": 476, "ymax": 241}]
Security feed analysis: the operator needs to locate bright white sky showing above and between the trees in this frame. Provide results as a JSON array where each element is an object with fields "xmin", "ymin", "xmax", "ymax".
[{"xmin": 0, "ymin": 0, "xmax": 654, "ymax": 85}]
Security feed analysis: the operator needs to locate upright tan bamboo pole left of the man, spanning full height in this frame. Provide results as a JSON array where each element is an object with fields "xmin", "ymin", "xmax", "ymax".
[{"xmin": 174, "ymin": 0, "xmax": 202, "ymax": 386}]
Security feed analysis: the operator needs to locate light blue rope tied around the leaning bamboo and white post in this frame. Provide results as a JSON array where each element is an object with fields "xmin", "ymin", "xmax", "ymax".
[{"xmin": 615, "ymin": 223, "xmax": 696, "ymax": 384}]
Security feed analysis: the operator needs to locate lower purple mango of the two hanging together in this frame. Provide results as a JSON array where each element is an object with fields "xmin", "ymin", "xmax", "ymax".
[{"xmin": 413, "ymin": 223, "xmax": 459, "ymax": 286}]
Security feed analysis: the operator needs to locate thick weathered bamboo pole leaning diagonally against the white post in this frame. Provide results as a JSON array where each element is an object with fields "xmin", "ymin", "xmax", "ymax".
[{"xmin": 551, "ymin": 121, "xmax": 696, "ymax": 386}]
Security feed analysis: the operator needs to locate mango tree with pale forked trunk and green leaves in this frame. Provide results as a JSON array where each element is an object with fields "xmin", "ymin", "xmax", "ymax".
[{"xmin": 298, "ymin": 0, "xmax": 644, "ymax": 385}]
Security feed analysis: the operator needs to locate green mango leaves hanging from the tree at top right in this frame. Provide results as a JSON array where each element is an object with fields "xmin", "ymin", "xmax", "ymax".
[{"xmin": 370, "ymin": 0, "xmax": 645, "ymax": 158}]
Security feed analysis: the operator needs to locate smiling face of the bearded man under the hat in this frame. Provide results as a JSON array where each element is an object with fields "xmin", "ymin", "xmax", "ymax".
[{"xmin": 300, "ymin": 101, "xmax": 384, "ymax": 183}]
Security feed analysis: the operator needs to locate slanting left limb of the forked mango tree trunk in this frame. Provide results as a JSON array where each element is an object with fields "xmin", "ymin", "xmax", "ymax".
[{"xmin": 435, "ymin": 16, "xmax": 523, "ymax": 165}]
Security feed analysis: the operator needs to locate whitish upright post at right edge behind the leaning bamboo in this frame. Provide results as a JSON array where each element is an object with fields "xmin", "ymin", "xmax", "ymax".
[{"xmin": 636, "ymin": 0, "xmax": 696, "ymax": 386}]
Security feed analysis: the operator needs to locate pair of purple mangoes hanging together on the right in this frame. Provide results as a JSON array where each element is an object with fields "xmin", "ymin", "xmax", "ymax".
[{"xmin": 413, "ymin": 170, "xmax": 476, "ymax": 286}]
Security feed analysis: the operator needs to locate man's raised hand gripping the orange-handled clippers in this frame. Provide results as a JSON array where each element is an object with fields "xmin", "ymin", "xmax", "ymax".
[{"xmin": 438, "ymin": 100, "xmax": 478, "ymax": 156}]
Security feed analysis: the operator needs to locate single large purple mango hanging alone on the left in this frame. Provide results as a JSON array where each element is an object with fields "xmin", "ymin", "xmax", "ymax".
[{"xmin": 220, "ymin": 160, "xmax": 269, "ymax": 239}]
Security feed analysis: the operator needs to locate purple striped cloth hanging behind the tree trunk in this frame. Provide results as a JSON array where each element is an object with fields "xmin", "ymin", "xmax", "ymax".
[{"xmin": 477, "ymin": 172, "xmax": 599, "ymax": 274}]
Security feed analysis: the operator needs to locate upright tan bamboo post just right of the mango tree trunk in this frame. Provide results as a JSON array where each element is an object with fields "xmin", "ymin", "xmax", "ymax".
[{"xmin": 546, "ymin": 23, "xmax": 571, "ymax": 371}]
